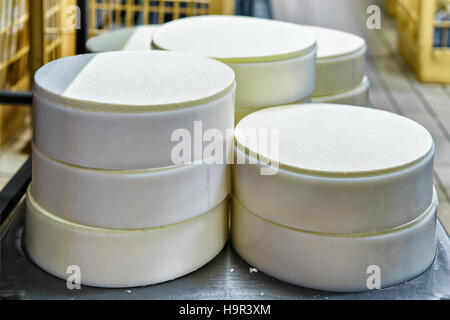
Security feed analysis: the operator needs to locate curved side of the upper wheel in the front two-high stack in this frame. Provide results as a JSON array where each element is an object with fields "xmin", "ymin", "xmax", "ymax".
[{"xmin": 233, "ymin": 145, "xmax": 433, "ymax": 233}]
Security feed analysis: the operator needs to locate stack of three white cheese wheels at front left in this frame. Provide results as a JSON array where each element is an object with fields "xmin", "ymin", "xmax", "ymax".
[{"xmin": 25, "ymin": 51, "xmax": 235, "ymax": 287}]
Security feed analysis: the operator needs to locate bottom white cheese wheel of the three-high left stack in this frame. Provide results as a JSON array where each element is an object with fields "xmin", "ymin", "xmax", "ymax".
[{"xmin": 25, "ymin": 192, "xmax": 228, "ymax": 287}]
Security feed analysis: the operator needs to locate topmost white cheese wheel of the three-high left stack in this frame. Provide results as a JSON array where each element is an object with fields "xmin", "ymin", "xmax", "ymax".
[{"xmin": 33, "ymin": 51, "xmax": 235, "ymax": 170}]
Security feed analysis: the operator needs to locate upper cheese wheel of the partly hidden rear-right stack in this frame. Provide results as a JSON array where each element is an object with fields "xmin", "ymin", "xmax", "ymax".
[{"xmin": 309, "ymin": 26, "xmax": 367, "ymax": 97}]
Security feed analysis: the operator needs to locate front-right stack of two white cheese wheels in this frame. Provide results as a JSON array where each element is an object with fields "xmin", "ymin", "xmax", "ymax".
[{"xmin": 231, "ymin": 104, "xmax": 437, "ymax": 291}]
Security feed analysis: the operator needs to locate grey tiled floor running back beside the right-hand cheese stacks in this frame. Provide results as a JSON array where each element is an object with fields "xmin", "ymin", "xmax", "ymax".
[{"xmin": 271, "ymin": 0, "xmax": 450, "ymax": 231}]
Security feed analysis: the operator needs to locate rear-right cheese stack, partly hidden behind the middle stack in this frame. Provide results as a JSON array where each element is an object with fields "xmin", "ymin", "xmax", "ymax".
[{"xmin": 311, "ymin": 26, "xmax": 369, "ymax": 106}]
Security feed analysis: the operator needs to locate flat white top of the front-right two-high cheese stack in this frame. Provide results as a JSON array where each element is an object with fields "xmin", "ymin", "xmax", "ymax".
[{"xmin": 235, "ymin": 104, "xmax": 434, "ymax": 176}]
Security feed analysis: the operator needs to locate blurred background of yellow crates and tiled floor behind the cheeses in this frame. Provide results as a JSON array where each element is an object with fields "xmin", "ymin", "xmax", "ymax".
[{"xmin": 0, "ymin": 0, "xmax": 450, "ymax": 229}]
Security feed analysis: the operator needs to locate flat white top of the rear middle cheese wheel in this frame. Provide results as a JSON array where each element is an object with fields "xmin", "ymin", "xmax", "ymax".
[{"xmin": 153, "ymin": 16, "xmax": 316, "ymax": 63}]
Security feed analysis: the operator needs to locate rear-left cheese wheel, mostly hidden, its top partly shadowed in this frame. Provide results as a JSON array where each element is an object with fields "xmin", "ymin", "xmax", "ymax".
[{"xmin": 86, "ymin": 25, "xmax": 158, "ymax": 52}]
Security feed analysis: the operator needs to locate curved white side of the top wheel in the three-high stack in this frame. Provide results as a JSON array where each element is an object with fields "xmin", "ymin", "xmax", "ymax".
[{"xmin": 33, "ymin": 79, "xmax": 234, "ymax": 170}]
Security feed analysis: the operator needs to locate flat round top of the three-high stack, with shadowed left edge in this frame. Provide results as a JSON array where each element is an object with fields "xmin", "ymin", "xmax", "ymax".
[{"xmin": 34, "ymin": 51, "xmax": 234, "ymax": 112}]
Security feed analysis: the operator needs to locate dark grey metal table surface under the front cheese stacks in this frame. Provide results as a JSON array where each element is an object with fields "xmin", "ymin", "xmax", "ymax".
[{"xmin": 0, "ymin": 201, "xmax": 450, "ymax": 300}]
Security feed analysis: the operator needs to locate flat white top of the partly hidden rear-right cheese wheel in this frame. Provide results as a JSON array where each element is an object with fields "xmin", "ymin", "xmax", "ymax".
[{"xmin": 310, "ymin": 26, "xmax": 366, "ymax": 59}]
